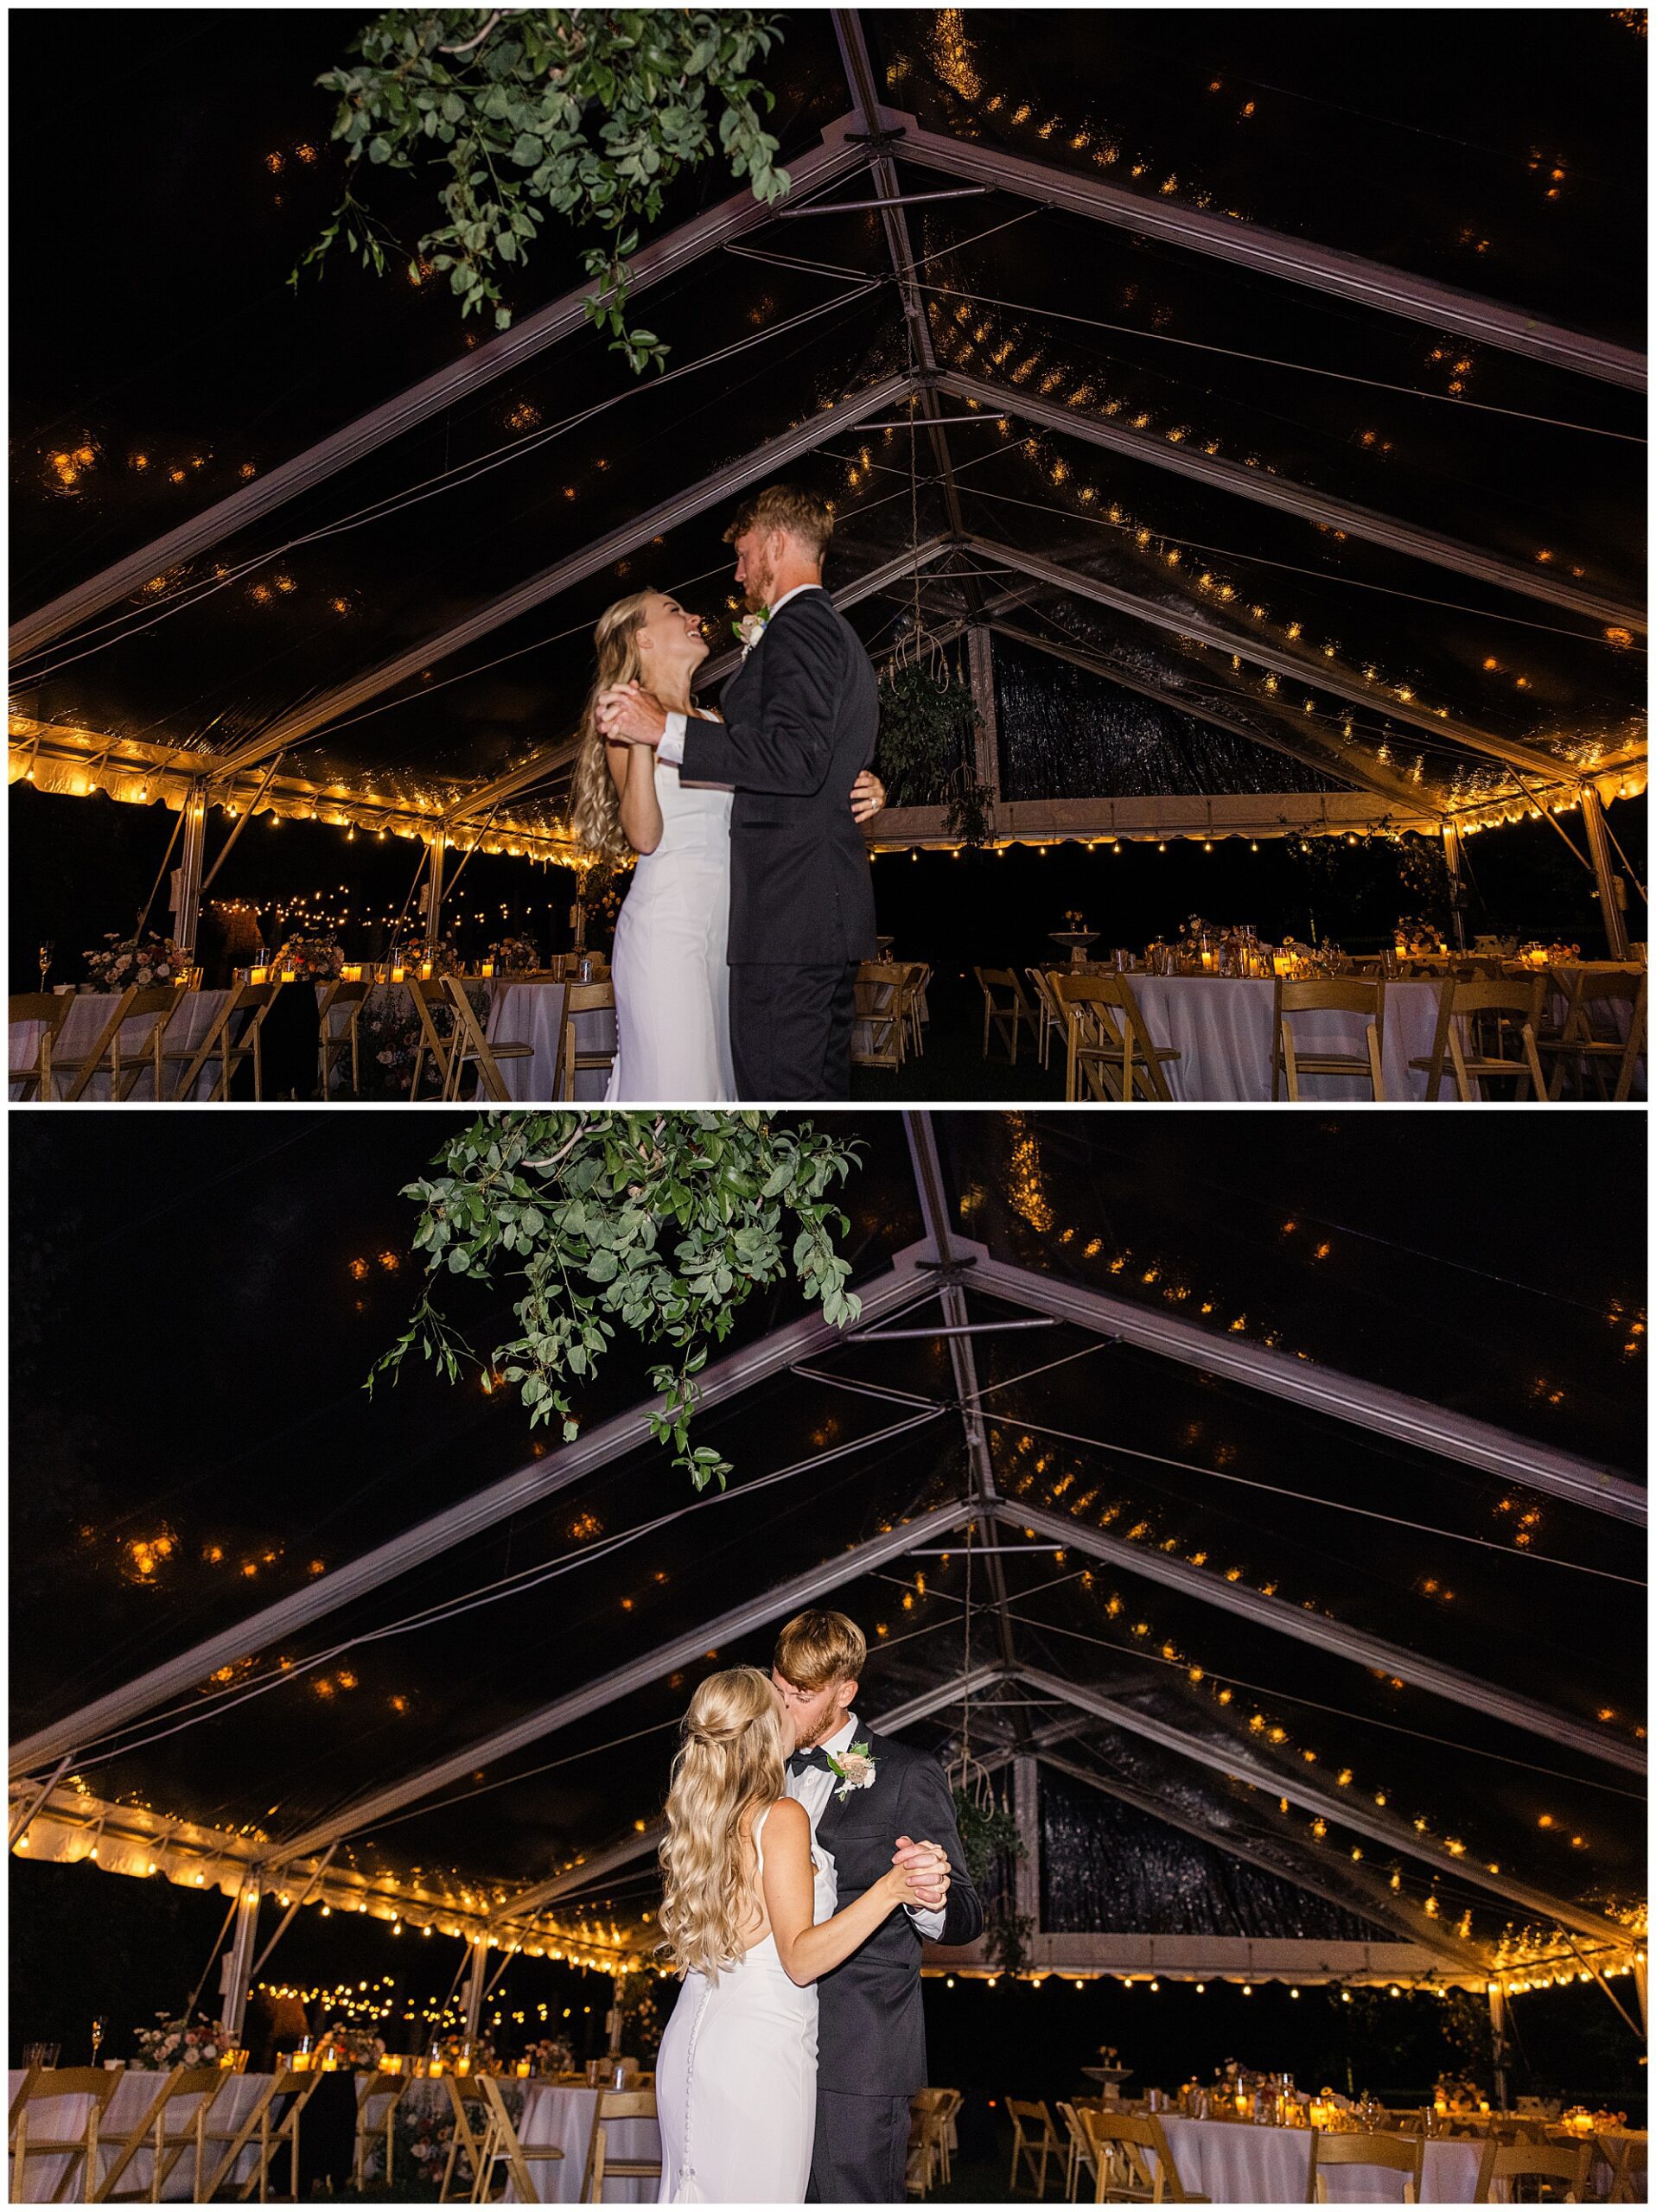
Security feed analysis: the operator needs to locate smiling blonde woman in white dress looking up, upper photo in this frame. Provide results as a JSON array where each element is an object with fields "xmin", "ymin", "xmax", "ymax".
[{"xmin": 571, "ymin": 591, "xmax": 886, "ymax": 1106}]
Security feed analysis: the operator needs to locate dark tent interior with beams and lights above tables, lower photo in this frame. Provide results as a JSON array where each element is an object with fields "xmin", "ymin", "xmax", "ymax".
[{"xmin": 11, "ymin": 1115, "xmax": 1647, "ymax": 2108}]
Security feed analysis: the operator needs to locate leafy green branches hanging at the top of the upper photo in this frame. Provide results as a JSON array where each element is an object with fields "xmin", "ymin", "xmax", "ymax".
[{"xmin": 292, "ymin": 9, "xmax": 788, "ymax": 372}]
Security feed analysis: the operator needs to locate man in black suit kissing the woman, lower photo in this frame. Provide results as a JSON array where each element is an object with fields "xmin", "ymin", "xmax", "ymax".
[{"xmin": 770, "ymin": 1612, "xmax": 983, "ymax": 2205}]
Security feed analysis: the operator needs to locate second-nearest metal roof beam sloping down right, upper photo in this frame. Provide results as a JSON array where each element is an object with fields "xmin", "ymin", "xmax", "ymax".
[{"xmin": 937, "ymin": 367, "xmax": 1645, "ymax": 641}]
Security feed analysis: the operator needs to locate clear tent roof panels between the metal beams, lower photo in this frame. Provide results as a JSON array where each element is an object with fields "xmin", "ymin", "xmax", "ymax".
[{"xmin": 11, "ymin": 1115, "xmax": 1645, "ymax": 1942}]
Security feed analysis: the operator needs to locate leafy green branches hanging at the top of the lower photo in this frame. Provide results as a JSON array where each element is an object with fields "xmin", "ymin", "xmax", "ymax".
[{"xmin": 367, "ymin": 1110, "xmax": 861, "ymax": 1491}]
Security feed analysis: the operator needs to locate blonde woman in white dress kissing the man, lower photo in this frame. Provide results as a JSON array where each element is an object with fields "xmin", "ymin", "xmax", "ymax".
[{"xmin": 655, "ymin": 1666, "xmax": 926, "ymax": 2205}]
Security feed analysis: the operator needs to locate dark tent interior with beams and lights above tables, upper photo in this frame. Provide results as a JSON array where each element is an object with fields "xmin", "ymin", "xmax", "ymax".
[{"xmin": 11, "ymin": 9, "xmax": 1645, "ymax": 995}]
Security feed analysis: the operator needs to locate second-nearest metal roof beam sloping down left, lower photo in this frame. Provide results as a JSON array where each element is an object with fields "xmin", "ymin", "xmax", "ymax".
[{"xmin": 265, "ymin": 1497, "xmax": 981, "ymax": 1867}]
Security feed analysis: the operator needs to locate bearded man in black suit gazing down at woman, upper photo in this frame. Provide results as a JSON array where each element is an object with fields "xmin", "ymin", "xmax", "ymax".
[{"xmin": 598, "ymin": 485, "xmax": 879, "ymax": 1103}]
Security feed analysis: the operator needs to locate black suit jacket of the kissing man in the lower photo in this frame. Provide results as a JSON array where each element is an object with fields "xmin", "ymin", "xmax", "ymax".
[{"xmin": 806, "ymin": 1725, "xmax": 983, "ymax": 2097}]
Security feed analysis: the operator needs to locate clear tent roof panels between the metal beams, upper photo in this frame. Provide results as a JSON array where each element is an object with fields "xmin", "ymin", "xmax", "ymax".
[{"xmin": 13, "ymin": 9, "xmax": 1643, "ymax": 825}]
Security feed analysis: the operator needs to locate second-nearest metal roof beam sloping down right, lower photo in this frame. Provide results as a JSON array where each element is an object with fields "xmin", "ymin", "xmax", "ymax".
[{"xmin": 1001, "ymin": 1497, "xmax": 1645, "ymax": 1774}]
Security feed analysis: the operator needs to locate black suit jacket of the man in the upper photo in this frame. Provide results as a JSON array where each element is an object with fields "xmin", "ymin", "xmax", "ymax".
[{"xmin": 682, "ymin": 591, "xmax": 879, "ymax": 967}]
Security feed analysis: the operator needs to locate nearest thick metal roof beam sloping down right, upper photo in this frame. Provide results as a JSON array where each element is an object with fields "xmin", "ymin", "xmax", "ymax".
[{"xmin": 881, "ymin": 108, "xmax": 1647, "ymax": 391}]
